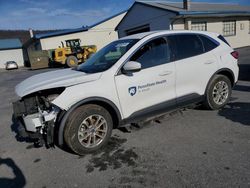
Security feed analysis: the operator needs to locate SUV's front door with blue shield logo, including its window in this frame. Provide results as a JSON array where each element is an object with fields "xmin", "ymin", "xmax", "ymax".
[{"xmin": 115, "ymin": 38, "xmax": 175, "ymax": 118}]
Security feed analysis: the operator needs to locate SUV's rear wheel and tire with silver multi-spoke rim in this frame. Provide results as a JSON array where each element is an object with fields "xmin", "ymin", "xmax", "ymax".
[{"xmin": 203, "ymin": 75, "xmax": 232, "ymax": 110}]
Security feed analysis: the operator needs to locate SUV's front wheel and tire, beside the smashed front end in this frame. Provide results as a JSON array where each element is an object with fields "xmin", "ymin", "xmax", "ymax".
[{"xmin": 64, "ymin": 104, "xmax": 113, "ymax": 155}]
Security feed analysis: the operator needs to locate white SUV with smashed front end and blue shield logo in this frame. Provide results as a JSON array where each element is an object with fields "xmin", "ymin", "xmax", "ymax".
[{"xmin": 13, "ymin": 31, "xmax": 239, "ymax": 155}]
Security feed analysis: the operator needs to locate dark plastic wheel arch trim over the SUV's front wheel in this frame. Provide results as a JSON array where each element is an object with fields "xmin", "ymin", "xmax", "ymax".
[{"xmin": 57, "ymin": 97, "xmax": 122, "ymax": 146}]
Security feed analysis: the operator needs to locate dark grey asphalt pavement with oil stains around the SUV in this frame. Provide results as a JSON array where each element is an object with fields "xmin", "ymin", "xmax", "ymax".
[{"xmin": 0, "ymin": 47, "xmax": 250, "ymax": 188}]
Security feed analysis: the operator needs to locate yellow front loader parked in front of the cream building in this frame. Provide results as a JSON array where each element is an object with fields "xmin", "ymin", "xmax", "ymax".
[{"xmin": 53, "ymin": 39, "xmax": 97, "ymax": 67}]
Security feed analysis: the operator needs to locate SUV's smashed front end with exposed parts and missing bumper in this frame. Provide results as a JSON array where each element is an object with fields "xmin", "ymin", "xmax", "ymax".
[{"xmin": 13, "ymin": 88, "xmax": 65, "ymax": 148}]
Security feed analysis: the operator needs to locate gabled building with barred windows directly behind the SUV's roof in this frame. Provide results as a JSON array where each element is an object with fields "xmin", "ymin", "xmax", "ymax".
[{"xmin": 116, "ymin": 0, "xmax": 250, "ymax": 48}]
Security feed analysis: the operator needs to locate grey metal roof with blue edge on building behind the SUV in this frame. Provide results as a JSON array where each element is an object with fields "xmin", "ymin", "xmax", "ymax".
[{"xmin": 138, "ymin": 1, "xmax": 250, "ymax": 16}]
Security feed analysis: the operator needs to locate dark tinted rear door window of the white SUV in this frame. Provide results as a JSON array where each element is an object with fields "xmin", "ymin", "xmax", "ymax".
[{"xmin": 168, "ymin": 34, "xmax": 204, "ymax": 60}]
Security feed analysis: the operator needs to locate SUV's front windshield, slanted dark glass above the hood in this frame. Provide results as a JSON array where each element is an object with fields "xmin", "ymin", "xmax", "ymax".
[{"xmin": 76, "ymin": 39, "xmax": 138, "ymax": 73}]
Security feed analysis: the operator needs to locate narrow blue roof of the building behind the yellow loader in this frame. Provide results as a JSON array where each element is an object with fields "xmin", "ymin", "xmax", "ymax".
[{"xmin": 34, "ymin": 10, "xmax": 127, "ymax": 39}]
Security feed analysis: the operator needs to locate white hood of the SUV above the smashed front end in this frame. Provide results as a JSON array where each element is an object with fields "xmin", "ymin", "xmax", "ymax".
[{"xmin": 15, "ymin": 69, "xmax": 101, "ymax": 97}]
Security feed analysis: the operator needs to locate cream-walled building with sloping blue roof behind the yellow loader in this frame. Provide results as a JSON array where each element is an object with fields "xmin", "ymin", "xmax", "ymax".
[{"xmin": 29, "ymin": 11, "xmax": 126, "ymax": 50}]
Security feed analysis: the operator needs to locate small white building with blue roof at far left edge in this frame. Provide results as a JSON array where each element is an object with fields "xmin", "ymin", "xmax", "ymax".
[{"xmin": 0, "ymin": 39, "xmax": 24, "ymax": 68}]
